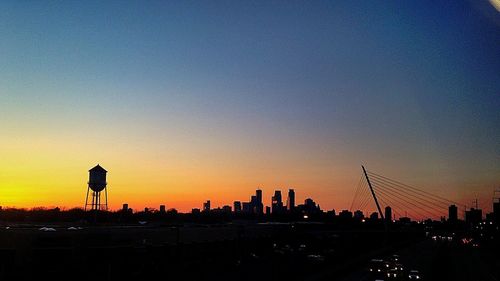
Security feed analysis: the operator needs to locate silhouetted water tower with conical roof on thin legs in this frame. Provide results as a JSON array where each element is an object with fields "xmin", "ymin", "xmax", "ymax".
[{"xmin": 85, "ymin": 165, "xmax": 108, "ymax": 211}]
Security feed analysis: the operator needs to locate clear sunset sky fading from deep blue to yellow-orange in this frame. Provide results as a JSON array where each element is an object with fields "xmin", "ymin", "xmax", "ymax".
[{"xmin": 0, "ymin": 1, "xmax": 500, "ymax": 211}]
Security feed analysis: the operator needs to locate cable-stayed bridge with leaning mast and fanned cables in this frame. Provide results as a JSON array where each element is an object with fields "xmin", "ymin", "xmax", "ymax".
[{"xmin": 350, "ymin": 164, "xmax": 465, "ymax": 220}]
